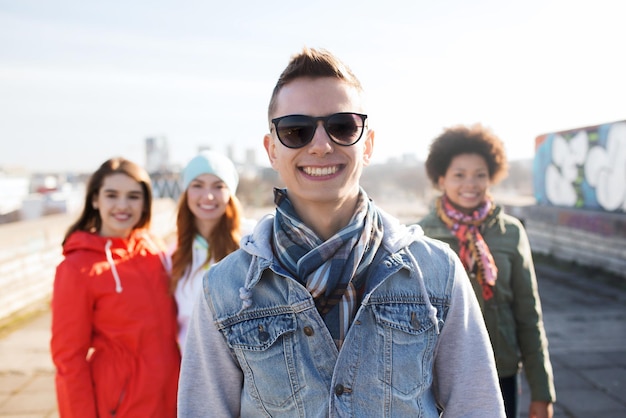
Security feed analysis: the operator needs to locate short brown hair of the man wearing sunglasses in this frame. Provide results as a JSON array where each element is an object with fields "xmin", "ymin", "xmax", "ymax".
[{"xmin": 267, "ymin": 47, "xmax": 363, "ymax": 118}]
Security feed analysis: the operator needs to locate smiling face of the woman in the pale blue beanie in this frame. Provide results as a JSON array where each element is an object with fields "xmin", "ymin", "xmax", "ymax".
[{"xmin": 187, "ymin": 174, "xmax": 231, "ymax": 238}]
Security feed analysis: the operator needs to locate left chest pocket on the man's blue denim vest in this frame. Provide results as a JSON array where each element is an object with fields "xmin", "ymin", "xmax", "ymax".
[{"xmin": 223, "ymin": 313, "xmax": 302, "ymax": 410}]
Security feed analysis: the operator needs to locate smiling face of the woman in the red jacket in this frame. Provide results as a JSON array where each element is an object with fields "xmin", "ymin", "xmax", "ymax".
[{"xmin": 92, "ymin": 173, "xmax": 145, "ymax": 238}]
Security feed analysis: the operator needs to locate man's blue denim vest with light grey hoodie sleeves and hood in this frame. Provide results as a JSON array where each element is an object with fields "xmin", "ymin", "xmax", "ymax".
[{"xmin": 178, "ymin": 211, "xmax": 504, "ymax": 418}]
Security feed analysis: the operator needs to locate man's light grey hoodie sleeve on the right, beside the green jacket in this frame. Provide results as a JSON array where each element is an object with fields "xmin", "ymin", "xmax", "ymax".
[{"xmin": 433, "ymin": 255, "xmax": 505, "ymax": 418}]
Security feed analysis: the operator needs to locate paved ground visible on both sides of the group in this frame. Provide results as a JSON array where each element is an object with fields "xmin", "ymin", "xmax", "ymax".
[{"xmin": 0, "ymin": 264, "xmax": 626, "ymax": 418}]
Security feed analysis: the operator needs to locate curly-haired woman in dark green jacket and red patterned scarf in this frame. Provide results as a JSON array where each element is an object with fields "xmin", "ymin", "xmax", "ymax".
[{"xmin": 419, "ymin": 125, "xmax": 556, "ymax": 418}]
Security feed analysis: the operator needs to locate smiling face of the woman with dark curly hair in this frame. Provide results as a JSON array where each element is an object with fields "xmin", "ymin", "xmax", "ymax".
[{"xmin": 438, "ymin": 154, "xmax": 490, "ymax": 214}]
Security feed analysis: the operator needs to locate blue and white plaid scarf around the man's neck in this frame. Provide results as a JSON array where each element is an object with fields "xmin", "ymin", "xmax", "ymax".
[{"xmin": 274, "ymin": 189, "xmax": 383, "ymax": 348}]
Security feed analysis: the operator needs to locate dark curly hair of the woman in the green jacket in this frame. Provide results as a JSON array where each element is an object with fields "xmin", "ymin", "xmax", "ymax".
[{"xmin": 425, "ymin": 124, "xmax": 509, "ymax": 187}]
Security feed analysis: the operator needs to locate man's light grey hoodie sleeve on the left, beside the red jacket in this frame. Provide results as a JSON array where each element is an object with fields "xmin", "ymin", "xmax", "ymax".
[{"xmin": 178, "ymin": 282, "xmax": 243, "ymax": 418}]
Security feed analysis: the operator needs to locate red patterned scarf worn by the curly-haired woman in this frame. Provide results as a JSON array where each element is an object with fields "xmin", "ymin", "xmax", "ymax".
[{"xmin": 436, "ymin": 195, "xmax": 498, "ymax": 300}]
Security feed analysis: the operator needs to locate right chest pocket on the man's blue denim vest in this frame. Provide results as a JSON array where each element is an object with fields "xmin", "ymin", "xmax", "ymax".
[{"xmin": 372, "ymin": 303, "xmax": 437, "ymax": 396}]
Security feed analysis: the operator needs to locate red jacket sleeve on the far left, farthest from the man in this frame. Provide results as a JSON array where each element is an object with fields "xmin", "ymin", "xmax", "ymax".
[{"xmin": 50, "ymin": 261, "xmax": 96, "ymax": 418}]
